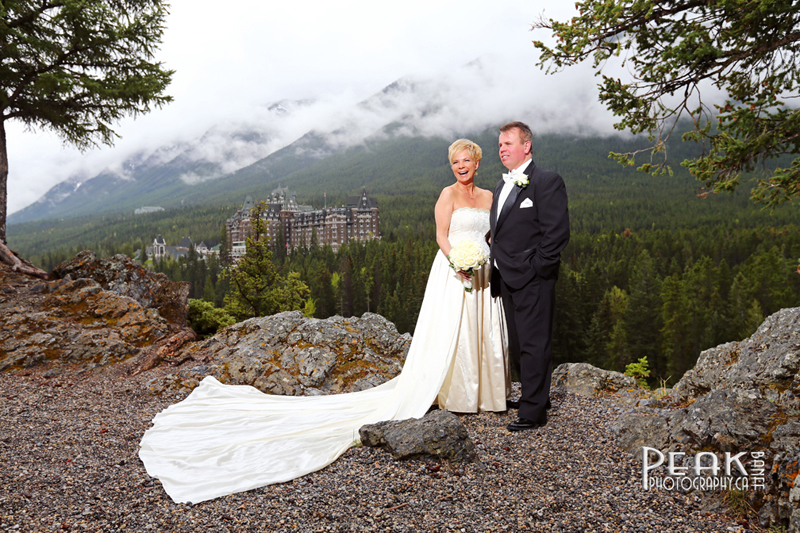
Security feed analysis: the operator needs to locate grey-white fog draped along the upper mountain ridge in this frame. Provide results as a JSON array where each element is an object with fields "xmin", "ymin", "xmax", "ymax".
[{"xmin": 9, "ymin": 57, "xmax": 614, "ymax": 224}]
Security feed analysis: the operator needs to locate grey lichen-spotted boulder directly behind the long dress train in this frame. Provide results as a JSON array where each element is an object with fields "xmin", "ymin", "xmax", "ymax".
[{"xmin": 149, "ymin": 311, "xmax": 411, "ymax": 396}]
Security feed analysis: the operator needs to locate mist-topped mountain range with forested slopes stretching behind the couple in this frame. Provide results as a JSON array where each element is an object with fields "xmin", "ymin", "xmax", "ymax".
[{"xmin": 8, "ymin": 62, "xmax": 796, "ymax": 249}]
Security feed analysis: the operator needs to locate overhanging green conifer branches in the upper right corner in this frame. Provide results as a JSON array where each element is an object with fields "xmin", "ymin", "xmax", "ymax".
[{"xmin": 534, "ymin": 0, "xmax": 800, "ymax": 205}]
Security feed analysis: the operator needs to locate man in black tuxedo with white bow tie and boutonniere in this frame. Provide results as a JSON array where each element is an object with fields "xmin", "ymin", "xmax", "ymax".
[{"xmin": 490, "ymin": 122, "xmax": 569, "ymax": 431}]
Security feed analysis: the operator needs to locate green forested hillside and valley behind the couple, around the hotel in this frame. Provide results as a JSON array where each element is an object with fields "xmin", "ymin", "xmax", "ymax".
[{"xmin": 9, "ymin": 130, "xmax": 800, "ymax": 383}]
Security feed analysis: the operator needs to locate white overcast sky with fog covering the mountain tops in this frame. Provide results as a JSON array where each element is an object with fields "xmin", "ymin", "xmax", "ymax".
[{"xmin": 6, "ymin": 0, "xmax": 744, "ymax": 221}]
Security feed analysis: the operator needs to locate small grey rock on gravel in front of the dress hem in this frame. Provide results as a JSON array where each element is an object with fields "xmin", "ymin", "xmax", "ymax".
[{"xmin": 358, "ymin": 409, "xmax": 478, "ymax": 463}]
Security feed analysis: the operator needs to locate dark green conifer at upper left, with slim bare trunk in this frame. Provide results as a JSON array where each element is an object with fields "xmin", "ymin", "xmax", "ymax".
[{"xmin": 0, "ymin": 0, "xmax": 173, "ymax": 247}]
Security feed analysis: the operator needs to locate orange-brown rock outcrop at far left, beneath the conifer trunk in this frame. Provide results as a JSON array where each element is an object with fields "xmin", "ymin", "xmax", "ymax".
[{"xmin": 0, "ymin": 252, "xmax": 194, "ymax": 370}]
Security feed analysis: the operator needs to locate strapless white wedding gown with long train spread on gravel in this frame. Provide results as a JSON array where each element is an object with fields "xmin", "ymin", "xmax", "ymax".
[{"xmin": 139, "ymin": 208, "xmax": 509, "ymax": 503}]
